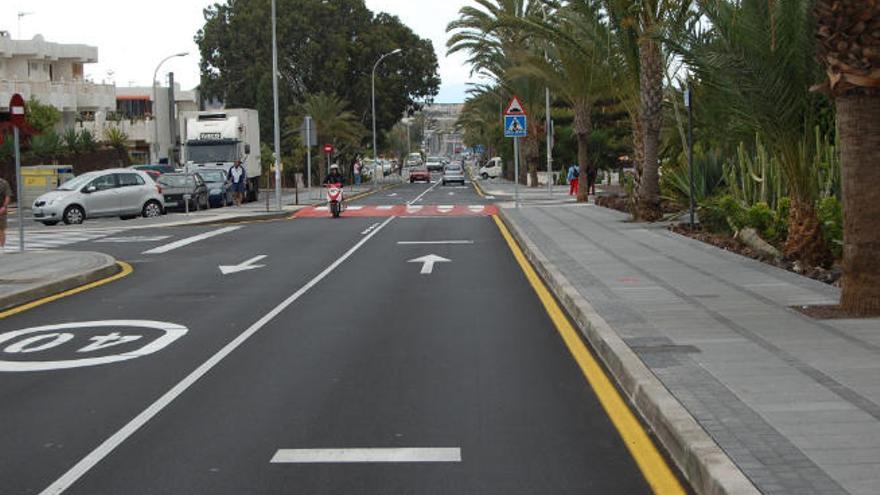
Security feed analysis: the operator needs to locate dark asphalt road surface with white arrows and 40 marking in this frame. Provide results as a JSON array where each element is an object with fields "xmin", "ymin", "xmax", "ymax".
[{"xmin": 0, "ymin": 179, "xmax": 664, "ymax": 494}]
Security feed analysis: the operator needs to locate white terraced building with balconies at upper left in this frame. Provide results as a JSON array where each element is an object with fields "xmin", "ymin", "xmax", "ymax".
[{"xmin": 0, "ymin": 31, "xmax": 116, "ymax": 127}]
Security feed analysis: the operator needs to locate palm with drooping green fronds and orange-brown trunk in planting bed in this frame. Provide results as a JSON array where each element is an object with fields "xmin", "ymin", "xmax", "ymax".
[{"xmin": 677, "ymin": 0, "xmax": 829, "ymax": 266}]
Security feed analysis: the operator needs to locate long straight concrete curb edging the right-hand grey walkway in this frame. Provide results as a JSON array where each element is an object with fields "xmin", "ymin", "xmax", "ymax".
[{"xmin": 499, "ymin": 209, "xmax": 760, "ymax": 495}]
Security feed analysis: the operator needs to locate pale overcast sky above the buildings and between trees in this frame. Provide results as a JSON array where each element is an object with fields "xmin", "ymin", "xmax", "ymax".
[{"xmin": 0, "ymin": 0, "xmax": 478, "ymax": 103}]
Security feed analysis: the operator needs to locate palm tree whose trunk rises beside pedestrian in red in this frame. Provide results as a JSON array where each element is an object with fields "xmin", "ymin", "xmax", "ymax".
[{"xmin": 502, "ymin": 1, "xmax": 611, "ymax": 202}]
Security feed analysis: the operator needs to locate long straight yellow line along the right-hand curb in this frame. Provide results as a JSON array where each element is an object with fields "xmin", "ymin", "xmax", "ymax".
[{"xmin": 492, "ymin": 215, "xmax": 686, "ymax": 495}]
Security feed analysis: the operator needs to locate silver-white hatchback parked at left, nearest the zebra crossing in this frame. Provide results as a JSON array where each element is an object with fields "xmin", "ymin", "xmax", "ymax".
[{"xmin": 33, "ymin": 168, "xmax": 165, "ymax": 225}]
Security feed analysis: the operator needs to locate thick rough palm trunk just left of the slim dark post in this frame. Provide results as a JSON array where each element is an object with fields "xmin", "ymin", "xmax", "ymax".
[{"xmin": 636, "ymin": 39, "xmax": 663, "ymax": 221}]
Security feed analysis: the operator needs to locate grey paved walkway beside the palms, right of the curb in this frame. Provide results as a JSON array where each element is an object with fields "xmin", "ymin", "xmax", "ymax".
[{"xmin": 504, "ymin": 204, "xmax": 880, "ymax": 495}]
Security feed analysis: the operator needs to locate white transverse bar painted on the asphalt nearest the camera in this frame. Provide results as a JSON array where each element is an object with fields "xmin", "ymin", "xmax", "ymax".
[{"xmin": 269, "ymin": 447, "xmax": 461, "ymax": 464}]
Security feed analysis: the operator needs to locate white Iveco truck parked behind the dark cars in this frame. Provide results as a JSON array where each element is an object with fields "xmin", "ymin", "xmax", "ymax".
[{"xmin": 181, "ymin": 108, "xmax": 262, "ymax": 201}]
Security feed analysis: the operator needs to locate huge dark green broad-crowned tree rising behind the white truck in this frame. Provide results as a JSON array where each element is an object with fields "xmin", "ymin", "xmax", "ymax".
[{"xmin": 195, "ymin": 0, "xmax": 440, "ymax": 147}]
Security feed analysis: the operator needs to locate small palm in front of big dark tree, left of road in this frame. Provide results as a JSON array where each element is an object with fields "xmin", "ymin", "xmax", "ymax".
[{"xmin": 287, "ymin": 92, "xmax": 367, "ymax": 183}]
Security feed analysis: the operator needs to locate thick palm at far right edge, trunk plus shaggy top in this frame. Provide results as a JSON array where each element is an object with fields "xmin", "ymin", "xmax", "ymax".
[{"xmin": 814, "ymin": 0, "xmax": 880, "ymax": 314}]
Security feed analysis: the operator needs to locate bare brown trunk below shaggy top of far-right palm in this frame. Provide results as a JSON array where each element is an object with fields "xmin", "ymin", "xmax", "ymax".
[{"xmin": 835, "ymin": 94, "xmax": 880, "ymax": 314}]
